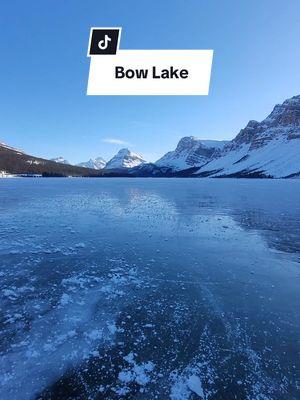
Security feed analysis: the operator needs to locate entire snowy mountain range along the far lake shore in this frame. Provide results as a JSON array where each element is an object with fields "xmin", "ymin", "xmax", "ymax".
[{"xmin": 0, "ymin": 95, "xmax": 300, "ymax": 178}]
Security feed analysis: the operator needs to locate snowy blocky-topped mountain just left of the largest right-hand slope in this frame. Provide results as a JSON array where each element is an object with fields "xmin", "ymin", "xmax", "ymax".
[{"xmin": 155, "ymin": 136, "xmax": 228, "ymax": 171}]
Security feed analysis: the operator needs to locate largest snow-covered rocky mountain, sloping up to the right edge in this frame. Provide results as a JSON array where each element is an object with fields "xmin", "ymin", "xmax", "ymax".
[{"xmin": 198, "ymin": 95, "xmax": 300, "ymax": 178}]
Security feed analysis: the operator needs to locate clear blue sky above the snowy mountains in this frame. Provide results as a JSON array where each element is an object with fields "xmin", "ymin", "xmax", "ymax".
[{"xmin": 0, "ymin": 0, "xmax": 300, "ymax": 162}]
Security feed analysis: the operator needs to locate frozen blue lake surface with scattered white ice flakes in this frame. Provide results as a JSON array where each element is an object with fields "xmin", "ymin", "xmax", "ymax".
[{"xmin": 0, "ymin": 178, "xmax": 300, "ymax": 400}]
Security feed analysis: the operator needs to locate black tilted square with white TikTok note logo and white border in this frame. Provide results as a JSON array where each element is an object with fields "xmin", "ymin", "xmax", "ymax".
[{"xmin": 88, "ymin": 28, "xmax": 121, "ymax": 56}]
